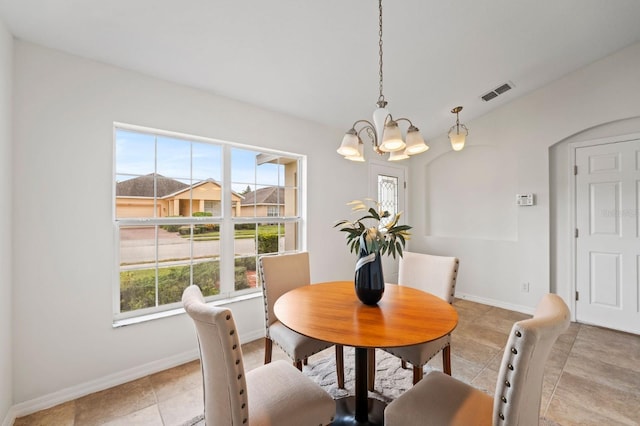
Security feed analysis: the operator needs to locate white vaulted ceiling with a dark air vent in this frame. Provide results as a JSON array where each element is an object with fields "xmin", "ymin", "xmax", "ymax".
[{"xmin": 0, "ymin": 0, "xmax": 640, "ymax": 138}]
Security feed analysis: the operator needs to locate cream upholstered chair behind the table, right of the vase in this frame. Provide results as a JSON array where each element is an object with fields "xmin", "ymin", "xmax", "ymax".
[{"xmin": 369, "ymin": 251, "xmax": 460, "ymax": 390}]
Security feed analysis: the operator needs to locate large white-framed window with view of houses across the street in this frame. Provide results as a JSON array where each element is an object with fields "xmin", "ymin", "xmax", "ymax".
[{"xmin": 114, "ymin": 124, "xmax": 302, "ymax": 319}]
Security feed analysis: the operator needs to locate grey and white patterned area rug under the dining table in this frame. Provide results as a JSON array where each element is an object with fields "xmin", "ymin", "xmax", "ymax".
[{"xmin": 181, "ymin": 347, "xmax": 561, "ymax": 426}]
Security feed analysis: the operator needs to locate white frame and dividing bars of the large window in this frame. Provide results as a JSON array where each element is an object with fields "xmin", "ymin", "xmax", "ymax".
[{"xmin": 112, "ymin": 122, "xmax": 307, "ymax": 327}]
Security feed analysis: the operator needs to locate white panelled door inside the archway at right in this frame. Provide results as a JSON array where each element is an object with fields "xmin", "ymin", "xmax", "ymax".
[{"xmin": 575, "ymin": 139, "xmax": 640, "ymax": 334}]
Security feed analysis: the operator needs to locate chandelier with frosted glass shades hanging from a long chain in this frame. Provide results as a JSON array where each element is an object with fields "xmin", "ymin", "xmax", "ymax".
[{"xmin": 337, "ymin": 0, "xmax": 429, "ymax": 161}]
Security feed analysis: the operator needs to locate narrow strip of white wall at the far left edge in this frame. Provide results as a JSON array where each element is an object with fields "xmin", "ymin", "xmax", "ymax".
[{"xmin": 0, "ymin": 17, "xmax": 13, "ymax": 424}]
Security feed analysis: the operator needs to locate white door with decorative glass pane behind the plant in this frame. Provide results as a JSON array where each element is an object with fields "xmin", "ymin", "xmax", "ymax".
[{"xmin": 369, "ymin": 163, "xmax": 406, "ymax": 283}]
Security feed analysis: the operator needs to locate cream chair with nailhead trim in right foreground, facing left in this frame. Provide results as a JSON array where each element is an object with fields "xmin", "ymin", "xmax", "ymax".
[{"xmin": 384, "ymin": 294, "xmax": 570, "ymax": 426}]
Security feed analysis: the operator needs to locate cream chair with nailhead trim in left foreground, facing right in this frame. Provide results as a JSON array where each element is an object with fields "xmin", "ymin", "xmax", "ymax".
[{"xmin": 182, "ymin": 285, "xmax": 336, "ymax": 426}]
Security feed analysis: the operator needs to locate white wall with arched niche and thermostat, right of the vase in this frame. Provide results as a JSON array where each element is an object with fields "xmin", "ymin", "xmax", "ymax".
[{"xmin": 409, "ymin": 40, "xmax": 640, "ymax": 312}]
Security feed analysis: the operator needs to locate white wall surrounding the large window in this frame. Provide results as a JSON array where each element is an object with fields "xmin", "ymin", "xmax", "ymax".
[{"xmin": 13, "ymin": 42, "xmax": 367, "ymax": 411}]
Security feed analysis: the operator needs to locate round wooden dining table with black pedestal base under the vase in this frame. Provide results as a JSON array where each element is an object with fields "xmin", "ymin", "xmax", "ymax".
[{"xmin": 274, "ymin": 281, "xmax": 458, "ymax": 426}]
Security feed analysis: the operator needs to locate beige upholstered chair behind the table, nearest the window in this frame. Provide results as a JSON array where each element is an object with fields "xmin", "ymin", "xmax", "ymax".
[{"xmin": 258, "ymin": 252, "xmax": 344, "ymax": 388}]
